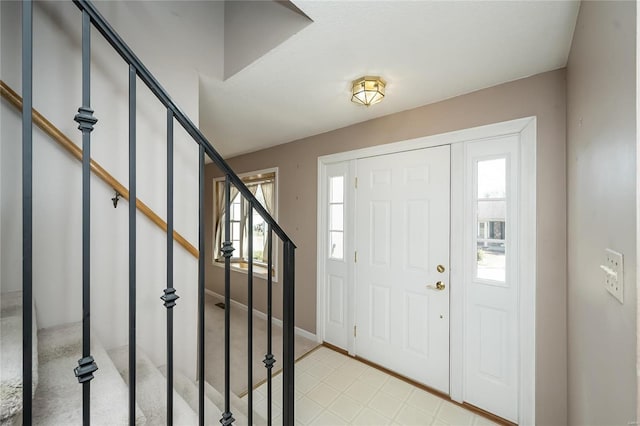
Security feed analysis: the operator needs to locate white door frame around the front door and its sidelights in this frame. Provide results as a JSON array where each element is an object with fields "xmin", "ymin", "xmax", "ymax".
[{"xmin": 316, "ymin": 116, "xmax": 537, "ymax": 424}]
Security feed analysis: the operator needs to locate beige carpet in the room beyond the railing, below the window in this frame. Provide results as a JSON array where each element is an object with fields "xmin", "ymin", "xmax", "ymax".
[{"xmin": 205, "ymin": 294, "xmax": 318, "ymax": 396}]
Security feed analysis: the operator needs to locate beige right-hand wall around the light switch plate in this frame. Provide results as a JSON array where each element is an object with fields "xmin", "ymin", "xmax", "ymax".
[{"xmin": 567, "ymin": 2, "xmax": 637, "ymax": 425}]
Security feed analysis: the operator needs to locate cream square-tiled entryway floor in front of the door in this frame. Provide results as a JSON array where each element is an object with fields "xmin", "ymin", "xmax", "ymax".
[{"xmin": 243, "ymin": 347, "xmax": 495, "ymax": 426}]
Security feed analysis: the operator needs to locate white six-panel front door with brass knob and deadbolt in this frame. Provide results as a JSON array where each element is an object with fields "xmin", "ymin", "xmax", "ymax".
[{"xmin": 355, "ymin": 145, "xmax": 450, "ymax": 393}]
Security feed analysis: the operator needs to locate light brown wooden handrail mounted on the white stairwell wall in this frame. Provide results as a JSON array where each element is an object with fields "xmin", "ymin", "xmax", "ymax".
[{"xmin": 0, "ymin": 80, "xmax": 199, "ymax": 258}]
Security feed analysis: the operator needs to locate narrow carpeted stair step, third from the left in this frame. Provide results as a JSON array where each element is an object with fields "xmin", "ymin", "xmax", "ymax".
[{"xmin": 109, "ymin": 346, "xmax": 198, "ymax": 426}]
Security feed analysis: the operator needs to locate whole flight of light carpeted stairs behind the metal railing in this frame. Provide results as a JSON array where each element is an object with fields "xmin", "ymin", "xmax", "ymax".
[{"xmin": 0, "ymin": 292, "xmax": 278, "ymax": 426}]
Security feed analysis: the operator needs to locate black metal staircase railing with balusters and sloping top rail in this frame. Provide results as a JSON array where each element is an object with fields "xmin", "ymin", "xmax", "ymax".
[{"xmin": 22, "ymin": 0, "xmax": 296, "ymax": 425}]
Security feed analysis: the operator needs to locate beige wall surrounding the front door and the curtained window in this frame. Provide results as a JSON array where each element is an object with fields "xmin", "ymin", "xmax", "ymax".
[{"xmin": 206, "ymin": 70, "xmax": 567, "ymax": 425}]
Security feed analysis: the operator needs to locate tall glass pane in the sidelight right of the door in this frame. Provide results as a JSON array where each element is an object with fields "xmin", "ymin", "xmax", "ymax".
[{"xmin": 476, "ymin": 158, "xmax": 507, "ymax": 282}]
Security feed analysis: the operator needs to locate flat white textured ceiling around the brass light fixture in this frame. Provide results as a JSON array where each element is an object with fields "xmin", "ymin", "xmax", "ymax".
[{"xmin": 200, "ymin": 1, "xmax": 579, "ymax": 157}]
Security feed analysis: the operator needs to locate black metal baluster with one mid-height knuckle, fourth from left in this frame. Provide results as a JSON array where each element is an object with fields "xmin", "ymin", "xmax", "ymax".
[{"xmin": 160, "ymin": 108, "xmax": 180, "ymax": 425}]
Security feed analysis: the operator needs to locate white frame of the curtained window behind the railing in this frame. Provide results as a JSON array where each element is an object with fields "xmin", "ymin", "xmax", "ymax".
[{"xmin": 211, "ymin": 167, "xmax": 279, "ymax": 282}]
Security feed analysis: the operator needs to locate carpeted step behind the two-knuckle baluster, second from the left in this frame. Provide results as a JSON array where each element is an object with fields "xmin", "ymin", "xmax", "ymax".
[{"xmin": 33, "ymin": 322, "xmax": 146, "ymax": 425}]
